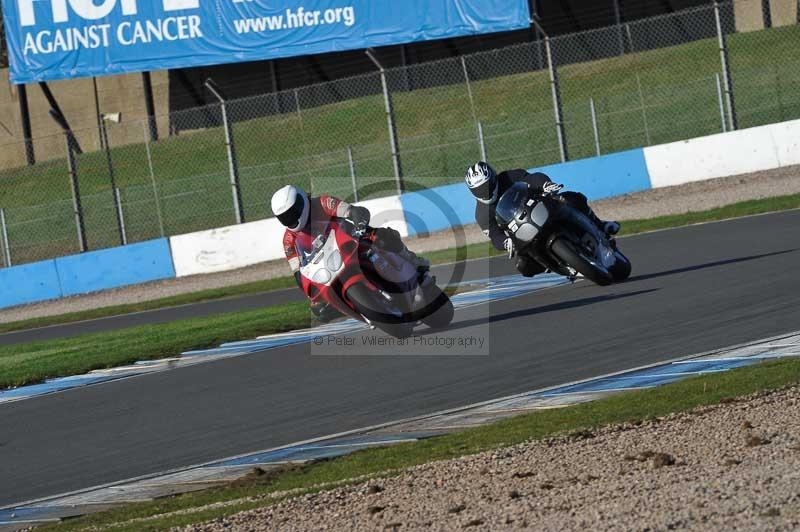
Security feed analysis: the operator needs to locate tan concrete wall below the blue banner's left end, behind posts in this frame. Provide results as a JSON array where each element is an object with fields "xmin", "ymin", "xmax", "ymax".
[{"xmin": 0, "ymin": 69, "xmax": 169, "ymax": 169}]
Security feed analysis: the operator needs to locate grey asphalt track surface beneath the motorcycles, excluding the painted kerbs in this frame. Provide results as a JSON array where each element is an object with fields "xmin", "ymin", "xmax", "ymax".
[{"xmin": 0, "ymin": 211, "xmax": 800, "ymax": 506}]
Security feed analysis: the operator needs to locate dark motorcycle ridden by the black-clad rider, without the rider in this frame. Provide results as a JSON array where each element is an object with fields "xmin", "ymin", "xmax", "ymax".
[{"xmin": 496, "ymin": 183, "xmax": 631, "ymax": 286}]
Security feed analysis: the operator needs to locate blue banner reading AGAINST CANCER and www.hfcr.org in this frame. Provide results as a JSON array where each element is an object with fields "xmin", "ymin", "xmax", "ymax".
[{"xmin": 2, "ymin": 0, "xmax": 530, "ymax": 83}]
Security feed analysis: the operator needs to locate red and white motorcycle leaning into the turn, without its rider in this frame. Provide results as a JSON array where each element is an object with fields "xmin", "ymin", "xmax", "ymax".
[{"xmin": 295, "ymin": 218, "xmax": 454, "ymax": 338}]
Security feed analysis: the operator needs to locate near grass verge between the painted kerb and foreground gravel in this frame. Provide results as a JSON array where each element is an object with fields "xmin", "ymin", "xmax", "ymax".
[{"xmin": 43, "ymin": 359, "xmax": 800, "ymax": 531}]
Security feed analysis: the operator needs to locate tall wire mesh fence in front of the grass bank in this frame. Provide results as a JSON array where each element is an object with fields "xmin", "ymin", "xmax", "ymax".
[{"xmin": 0, "ymin": 0, "xmax": 800, "ymax": 266}]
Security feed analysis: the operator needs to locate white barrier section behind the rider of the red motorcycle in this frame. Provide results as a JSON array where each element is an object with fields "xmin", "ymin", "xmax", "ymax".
[{"xmin": 170, "ymin": 196, "xmax": 408, "ymax": 277}]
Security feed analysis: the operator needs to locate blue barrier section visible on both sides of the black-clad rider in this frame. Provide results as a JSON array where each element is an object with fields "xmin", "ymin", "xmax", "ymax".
[{"xmin": 400, "ymin": 149, "xmax": 650, "ymax": 236}]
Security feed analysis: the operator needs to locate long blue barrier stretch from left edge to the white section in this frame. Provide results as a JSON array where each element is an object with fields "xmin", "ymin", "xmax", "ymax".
[{"xmin": 0, "ymin": 238, "xmax": 175, "ymax": 308}]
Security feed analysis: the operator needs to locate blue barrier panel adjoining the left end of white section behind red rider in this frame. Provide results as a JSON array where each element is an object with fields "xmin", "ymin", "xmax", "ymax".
[{"xmin": 56, "ymin": 238, "xmax": 175, "ymax": 296}]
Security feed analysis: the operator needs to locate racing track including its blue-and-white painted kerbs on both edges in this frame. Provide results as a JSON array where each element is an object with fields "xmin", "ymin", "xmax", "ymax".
[{"xmin": 0, "ymin": 211, "xmax": 800, "ymax": 525}]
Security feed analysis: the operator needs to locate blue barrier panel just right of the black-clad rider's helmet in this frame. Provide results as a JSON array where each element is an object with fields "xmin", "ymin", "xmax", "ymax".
[{"xmin": 530, "ymin": 149, "xmax": 652, "ymax": 200}]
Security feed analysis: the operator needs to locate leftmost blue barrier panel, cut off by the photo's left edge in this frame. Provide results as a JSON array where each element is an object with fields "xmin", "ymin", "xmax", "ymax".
[{"xmin": 0, "ymin": 260, "xmax": 61, "ymax": 308}]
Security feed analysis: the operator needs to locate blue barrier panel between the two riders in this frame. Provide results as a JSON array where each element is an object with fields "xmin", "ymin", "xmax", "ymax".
[{"xmin": 400, "ymin": 183, "xmax": 475, "ymax": 236}]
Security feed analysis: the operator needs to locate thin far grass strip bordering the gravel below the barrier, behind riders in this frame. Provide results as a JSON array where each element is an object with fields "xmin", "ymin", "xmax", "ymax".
[{"xmin": 0, "ymin": 194, "xmax": 800, "ymax": 334}]
